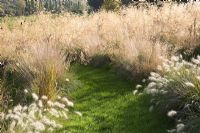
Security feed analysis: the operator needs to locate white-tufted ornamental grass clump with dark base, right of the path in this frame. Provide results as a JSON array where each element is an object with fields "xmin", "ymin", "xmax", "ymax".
[{"xmin": 145, "ymin": 56, "xmax": 200, "ymax": 132}]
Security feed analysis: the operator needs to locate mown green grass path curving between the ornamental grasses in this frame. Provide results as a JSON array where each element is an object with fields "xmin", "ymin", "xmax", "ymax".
[{"xmin": 62, "ymin": 65, "xmax": 172, "ymax": 133}]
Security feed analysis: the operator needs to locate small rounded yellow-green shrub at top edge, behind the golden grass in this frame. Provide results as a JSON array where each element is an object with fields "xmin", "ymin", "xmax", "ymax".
[{"xmin": 102, "ymin": 0, "xmax": 122, "ymax": 11}]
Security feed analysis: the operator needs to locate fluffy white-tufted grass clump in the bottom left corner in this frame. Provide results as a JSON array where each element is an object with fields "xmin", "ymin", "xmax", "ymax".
[{"xmin": 0, "ymin": 90, "xmax": 75, "ymax": 133}]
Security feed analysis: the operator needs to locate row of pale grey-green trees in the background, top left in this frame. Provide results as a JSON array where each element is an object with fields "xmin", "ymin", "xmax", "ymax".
[{"xmin": 0, "ymin": 0, "xmax": 87, "ymax": 16}]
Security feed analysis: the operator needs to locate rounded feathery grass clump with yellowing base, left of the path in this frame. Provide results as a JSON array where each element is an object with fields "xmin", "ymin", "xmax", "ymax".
[{"xmin": 15, "ymin": 44, "xmax": 68, "ymax": 99}]
